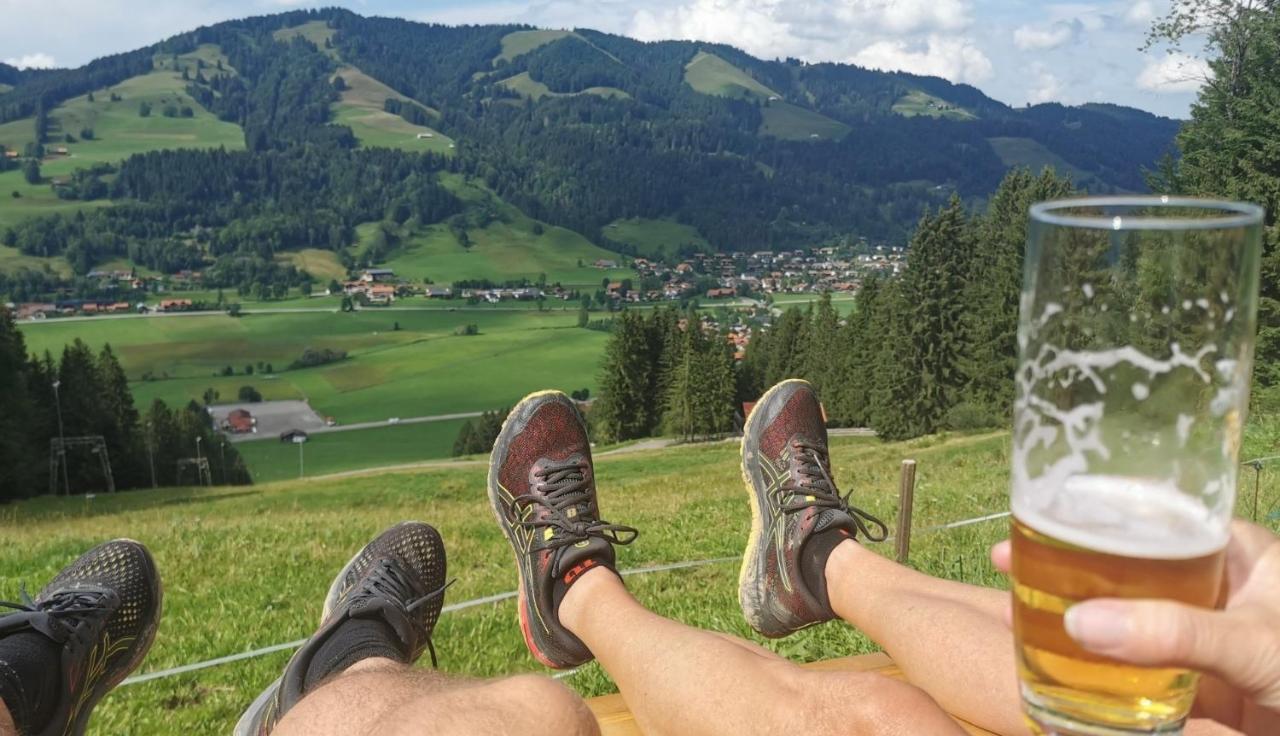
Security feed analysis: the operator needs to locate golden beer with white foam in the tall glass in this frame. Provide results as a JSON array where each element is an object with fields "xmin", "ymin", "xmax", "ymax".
[{"xmin": 1011, "ymin": 476, "xmax": 1226, "ymax": 735}]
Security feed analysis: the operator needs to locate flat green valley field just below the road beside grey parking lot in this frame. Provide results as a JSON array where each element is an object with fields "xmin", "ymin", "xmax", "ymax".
[{"xmin": 236, "ymin": 419, "xmax": 471, "ymax": 483}]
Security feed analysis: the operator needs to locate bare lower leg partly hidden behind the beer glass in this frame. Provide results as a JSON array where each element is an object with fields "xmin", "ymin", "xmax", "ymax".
[{"xmin": 827, "ymin": 541, "xmax": 1027, "ymax": 735}]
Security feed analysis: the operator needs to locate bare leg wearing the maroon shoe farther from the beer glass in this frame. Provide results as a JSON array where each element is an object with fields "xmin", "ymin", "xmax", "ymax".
[{"xmin": 559, "ymin": 568, "xmax": 963, "ymax": 736}]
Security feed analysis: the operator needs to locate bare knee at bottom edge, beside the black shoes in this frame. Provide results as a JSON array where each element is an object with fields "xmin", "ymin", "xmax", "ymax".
[{"xmin": 273, "ymin": 659, "xmax": 599, "ymax": 736}]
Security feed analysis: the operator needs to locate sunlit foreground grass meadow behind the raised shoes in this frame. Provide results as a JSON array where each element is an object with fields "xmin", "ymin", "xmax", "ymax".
[{"xmin": 0, "ymin": 421, "xmax": 1280, "ymax": 736}]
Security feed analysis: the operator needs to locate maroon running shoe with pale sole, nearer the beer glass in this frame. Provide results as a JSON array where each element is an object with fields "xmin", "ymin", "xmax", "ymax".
[{"xmin": 737, "ymin": 380, "xmax": 888, "ymax": 637}]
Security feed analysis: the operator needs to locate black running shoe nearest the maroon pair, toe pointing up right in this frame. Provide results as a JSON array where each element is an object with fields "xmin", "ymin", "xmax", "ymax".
[{"xmin": 234, "ymin": 521, "xmax": 448, "ymax": 736}]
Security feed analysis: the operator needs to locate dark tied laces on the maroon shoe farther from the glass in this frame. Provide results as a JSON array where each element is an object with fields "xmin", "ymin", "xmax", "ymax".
[{"xmin": 511, "ymin": 460, "xmax": 640, "ymax": 570}]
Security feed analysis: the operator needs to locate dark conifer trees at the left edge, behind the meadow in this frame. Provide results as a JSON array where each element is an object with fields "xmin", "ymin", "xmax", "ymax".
[{"xmin": 0, "ymin": 307, "xmax": 251, "ymax": 502}]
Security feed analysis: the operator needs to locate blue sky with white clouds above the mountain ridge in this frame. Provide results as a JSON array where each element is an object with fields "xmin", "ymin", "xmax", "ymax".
[{"xmin": 0, "ymin": 0, "xmax": 1207, "ymax": 118}]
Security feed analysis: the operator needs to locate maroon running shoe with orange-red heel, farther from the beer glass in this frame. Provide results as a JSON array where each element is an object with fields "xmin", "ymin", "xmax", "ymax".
[{"xmin": 489, "ymin": 390, "xmax": 636, "ymax": 669}]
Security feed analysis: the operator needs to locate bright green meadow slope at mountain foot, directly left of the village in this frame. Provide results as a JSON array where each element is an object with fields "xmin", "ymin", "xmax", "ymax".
[{"xmin": 387, "ymin": 174, "xmax": 632, "ymax": 289}]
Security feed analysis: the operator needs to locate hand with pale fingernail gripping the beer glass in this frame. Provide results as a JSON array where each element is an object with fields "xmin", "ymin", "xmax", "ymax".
[{"xmin": 992, "ymin": 521, "xmax": 1280, "ymax": 733}]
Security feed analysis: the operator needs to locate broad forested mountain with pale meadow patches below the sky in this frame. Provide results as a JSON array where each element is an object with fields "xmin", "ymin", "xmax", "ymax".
[{"xmin": 0, "ymin": 9, "xmax": 1179, "ymax": 280}]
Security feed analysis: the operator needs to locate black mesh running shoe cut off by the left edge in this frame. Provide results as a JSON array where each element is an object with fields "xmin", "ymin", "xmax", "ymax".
[{"xmin": 0, "ymin": 539, "xmax": 164, "ymax": 736}]
